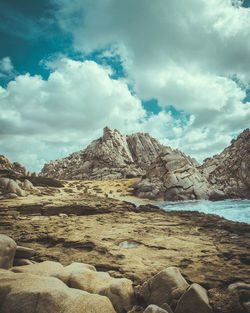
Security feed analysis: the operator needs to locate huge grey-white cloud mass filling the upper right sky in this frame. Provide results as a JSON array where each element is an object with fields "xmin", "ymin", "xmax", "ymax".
[{"xmin": 49, "ymin": 0, "xmax": 250, "ymax": 159}]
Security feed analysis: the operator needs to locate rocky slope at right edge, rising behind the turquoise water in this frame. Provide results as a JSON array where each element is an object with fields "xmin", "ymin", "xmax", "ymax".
[{"xmin": 201, "ymin": 129, "xmax": 250, "ymax": 199}]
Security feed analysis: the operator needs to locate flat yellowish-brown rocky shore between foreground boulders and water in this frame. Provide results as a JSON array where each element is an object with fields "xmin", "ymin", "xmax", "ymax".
[{"xmin": 0, "ymin": 187, "xmax": 250, "ymax": 313}]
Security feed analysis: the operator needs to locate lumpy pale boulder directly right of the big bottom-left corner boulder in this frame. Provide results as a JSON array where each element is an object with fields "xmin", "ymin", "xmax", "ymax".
[{"xmin": 55, "ymin": 263, "xmax": 134, "ymax": 313}]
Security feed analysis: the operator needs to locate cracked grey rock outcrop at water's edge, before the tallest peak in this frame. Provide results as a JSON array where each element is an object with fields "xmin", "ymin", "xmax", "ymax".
[{"xmin": 133, "ymin": 147, "xmax": 213, "ymax": 201}]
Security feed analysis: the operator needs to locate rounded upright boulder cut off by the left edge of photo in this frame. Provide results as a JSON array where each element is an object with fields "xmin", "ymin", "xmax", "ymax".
[{"xmin": 0, "ymin": 234, "xmax": 17, "ymax": 269}]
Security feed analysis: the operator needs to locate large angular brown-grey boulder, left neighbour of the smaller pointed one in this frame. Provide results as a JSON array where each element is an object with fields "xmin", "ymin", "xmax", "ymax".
[{"xmin": 137, "ymin": 267, "xmax": 189, "ymax": 307}]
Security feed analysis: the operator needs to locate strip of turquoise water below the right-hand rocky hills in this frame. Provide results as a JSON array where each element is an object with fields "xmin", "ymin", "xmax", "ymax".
[{"xmin": 157, "ymin": 199, "xmax": 250, "ymax": 224}]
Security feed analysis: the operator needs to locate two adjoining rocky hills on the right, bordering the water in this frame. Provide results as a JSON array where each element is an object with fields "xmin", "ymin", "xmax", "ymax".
[{"xmin": 133, "ymin": 129, "xmax": 250, "ymax": 201}]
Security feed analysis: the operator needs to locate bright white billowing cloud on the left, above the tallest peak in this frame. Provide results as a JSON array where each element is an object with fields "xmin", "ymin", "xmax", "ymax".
[{"xmin": 0, "ymin": 58, "xmax": 146, "ymax": 170}]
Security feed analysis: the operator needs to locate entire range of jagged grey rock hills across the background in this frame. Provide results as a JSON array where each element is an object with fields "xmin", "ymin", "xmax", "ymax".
[{"xmin": 41, "ymin": 127, "xmax": 250, "ymax": 201}]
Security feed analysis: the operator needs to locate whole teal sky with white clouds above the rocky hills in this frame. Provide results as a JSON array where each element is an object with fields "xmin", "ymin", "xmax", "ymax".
[{"xmin": 0, "ymin": 0, "xmax": 250, "ymax": 172}]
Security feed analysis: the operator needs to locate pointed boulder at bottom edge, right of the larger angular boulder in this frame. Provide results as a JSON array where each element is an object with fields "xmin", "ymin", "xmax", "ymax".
[{"xmin": 175, "ymin": 284, "xmax": 212, "ymax": 313}]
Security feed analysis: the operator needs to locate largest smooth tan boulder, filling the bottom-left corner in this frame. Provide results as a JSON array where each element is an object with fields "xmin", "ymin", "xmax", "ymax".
[{"xmin": 0, "ymin": 271, "xmax": 115, "ymax": 313}]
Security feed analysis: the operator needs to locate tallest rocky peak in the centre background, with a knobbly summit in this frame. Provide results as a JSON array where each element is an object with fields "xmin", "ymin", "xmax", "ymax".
[{"xmin": 41, "ymin": 127, "xmax": 163, "ymax": 180}]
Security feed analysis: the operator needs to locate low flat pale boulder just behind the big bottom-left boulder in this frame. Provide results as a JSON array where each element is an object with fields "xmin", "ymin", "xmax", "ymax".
[{"xmin": 11, "ymin": 261, "xmax": 63, "ymax": 276}]
